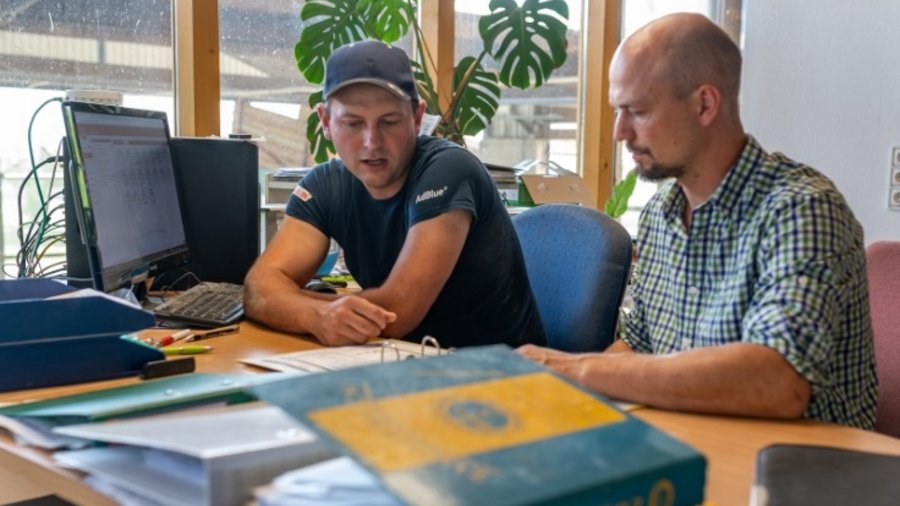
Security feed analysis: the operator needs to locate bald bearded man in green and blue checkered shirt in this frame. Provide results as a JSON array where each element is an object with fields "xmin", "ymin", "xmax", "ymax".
[{"xmin": 519, "ymin": 14, "xmax": 877, "ymax": 429}]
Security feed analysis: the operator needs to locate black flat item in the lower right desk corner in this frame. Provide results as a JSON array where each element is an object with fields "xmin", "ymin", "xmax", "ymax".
[{"xmin": 750, "ymin": 444, "xmax": 900, "ymax": 506}]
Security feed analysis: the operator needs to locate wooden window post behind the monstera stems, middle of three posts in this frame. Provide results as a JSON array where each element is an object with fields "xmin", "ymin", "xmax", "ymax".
[{"xmin": 419, "ymin": 0, "xmax": 456, "ymax": 111}]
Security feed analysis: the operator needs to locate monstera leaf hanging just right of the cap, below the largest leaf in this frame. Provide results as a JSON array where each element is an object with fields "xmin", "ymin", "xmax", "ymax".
[{"xmin": 453, "ymin": 56, "xmax": 500, "ymax": 135}]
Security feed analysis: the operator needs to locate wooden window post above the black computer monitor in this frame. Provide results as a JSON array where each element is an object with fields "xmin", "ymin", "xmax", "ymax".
[{"xmin": 174, "ymin": 0, "xmax": 220, "ymax": 136}]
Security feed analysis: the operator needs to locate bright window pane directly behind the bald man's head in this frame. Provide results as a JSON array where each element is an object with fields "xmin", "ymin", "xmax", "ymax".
[{"xmin": 616, "ymin": 0, "xmax": 741, "ymax": 236}]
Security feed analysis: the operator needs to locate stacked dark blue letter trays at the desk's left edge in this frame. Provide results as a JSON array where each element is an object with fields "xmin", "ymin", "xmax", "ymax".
[{"xmin": 0, "ymin": 279, "xmax": 165, "ymax": 391}]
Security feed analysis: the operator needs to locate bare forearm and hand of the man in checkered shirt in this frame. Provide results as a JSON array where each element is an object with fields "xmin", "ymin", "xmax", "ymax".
[{"xmin": 519, "ymin": 342, "xmax": 811, "ymax": 418}]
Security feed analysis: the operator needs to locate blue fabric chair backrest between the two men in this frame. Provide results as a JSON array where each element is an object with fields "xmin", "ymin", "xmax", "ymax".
[{"xmin": 513, "ymin": 204, "xmax": 631, "ymax": 351}]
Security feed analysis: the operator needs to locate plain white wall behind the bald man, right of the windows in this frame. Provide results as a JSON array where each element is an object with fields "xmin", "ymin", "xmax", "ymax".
[{"xmin": 741, "ymin": 0, "xmax": 900, "ymax": 244}]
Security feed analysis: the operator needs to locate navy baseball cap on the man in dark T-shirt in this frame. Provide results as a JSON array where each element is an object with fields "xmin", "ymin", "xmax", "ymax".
[{"xmin": 323, "ymin": 40, "xmax": 419, "ymax": 102}]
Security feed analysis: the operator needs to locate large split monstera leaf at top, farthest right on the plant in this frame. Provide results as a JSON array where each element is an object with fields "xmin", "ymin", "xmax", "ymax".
[{"xmin": 478, "ymin": 0, "xmax": 569, "ymax": 89}]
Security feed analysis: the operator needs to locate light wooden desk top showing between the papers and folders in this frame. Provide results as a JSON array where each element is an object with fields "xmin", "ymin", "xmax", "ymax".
[{"xmin": 0, "ymin": 322, "xmax": 900, "ymax": 506}]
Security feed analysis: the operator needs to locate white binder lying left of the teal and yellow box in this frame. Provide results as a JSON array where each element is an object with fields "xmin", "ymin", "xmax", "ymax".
[{"xmin": 54, "ymin": 403, "xmax": 334, "ymax": 506}]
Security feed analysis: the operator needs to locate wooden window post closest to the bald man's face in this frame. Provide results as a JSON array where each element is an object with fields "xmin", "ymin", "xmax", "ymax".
[{"xmin": 578, "ymin": 0, "xmax": 620, "ymax": 209}]
